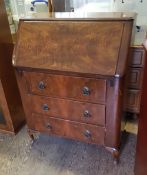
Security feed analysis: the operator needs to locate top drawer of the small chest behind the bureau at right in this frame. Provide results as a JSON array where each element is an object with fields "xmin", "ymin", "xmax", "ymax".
[{"xmin": 130, "ymin": 48, "xmax": 145, "ymax": 67}]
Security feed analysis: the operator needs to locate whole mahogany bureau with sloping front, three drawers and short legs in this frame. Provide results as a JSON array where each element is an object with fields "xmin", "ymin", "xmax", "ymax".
[{"xmin": 13, "ymin": 13, "xmax": 134, "ymax": 163}]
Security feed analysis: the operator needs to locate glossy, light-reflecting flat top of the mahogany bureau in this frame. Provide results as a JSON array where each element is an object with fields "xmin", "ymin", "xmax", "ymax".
[{"xmin": 21, "ymin": 12, "xmax": 136, "ymax": 20}]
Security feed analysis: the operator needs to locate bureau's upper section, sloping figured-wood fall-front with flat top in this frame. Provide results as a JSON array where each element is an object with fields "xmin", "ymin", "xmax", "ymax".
[{"xmin": 13, "ymin": 13, "xmax": 133, "ymax": 75}]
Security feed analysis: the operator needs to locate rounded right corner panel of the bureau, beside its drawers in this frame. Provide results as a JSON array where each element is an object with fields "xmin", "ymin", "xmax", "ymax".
[{"xmin": 105, "ymin": 78, "xmax": 124, "ymax": 149}]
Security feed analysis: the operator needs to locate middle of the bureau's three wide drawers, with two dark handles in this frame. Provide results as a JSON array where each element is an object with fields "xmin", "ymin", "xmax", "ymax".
[{"xmin": 30, "ymin": 96, "xmax": 105, "ymax": 126}]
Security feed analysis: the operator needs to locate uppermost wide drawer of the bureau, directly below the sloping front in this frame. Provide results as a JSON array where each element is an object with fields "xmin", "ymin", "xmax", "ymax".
[{"xmin": 24, "ymin": 72, "xmax": 106, "ymax": 103}]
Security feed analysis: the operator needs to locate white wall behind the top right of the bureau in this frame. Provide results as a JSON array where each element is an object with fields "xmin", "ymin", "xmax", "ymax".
[{"xmin": 67, "ymin": 0, "xmax": 147, "ymax": 25}]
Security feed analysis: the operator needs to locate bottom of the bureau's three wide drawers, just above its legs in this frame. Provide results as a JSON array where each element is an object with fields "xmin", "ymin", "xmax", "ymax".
[{"xmin": 31, "ymin": 114, "xmax": 105, "ymax": 144}]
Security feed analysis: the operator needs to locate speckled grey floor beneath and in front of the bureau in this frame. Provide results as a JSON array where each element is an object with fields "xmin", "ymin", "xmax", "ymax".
[{"xmin": 0, "ymin": 127, "xmax": 136, "ymax": 175}]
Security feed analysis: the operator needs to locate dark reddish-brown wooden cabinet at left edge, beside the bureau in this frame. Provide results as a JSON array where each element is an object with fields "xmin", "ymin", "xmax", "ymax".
[{"xmin": 0, "ymin": 0, "xmax": 24, "ymax": 132}]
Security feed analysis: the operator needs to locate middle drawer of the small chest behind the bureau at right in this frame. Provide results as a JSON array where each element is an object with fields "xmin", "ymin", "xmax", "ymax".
[{"xmin": 128, "ymin": 68, "xmax": 143, "ymax": 89}]
